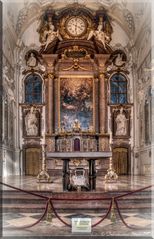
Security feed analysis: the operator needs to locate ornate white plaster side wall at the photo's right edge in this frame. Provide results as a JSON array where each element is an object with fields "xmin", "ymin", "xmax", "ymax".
[{"xmin": 133, "ymin": 23, "xmax": 152, "ymax": 175}]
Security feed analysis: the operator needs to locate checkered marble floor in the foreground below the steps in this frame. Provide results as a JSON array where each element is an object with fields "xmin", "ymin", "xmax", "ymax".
[{"xmin": 3, "ymin": 213, "xmax": 152, "ymax": 238}]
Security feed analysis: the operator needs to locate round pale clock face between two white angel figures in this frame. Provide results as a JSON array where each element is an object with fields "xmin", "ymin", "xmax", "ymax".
[{"xmin": 66, "ymin": 17, "xmax": 86, "ymax": 37}]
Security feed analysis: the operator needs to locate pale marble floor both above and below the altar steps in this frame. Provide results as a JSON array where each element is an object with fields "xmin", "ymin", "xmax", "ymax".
[{"xmin": 2, "ymin": 176, "xmax": 154, "ymax": 239}]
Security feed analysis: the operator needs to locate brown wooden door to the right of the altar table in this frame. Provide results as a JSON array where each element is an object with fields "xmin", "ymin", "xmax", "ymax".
[{"xmin": 113, "ymin": 147, "xmax": 128, "ymax": 175}]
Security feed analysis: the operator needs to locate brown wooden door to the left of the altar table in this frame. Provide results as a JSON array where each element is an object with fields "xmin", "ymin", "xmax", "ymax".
[{"xmin": 25, "ymin": 148, "xmax": 41, "ymax": 176}]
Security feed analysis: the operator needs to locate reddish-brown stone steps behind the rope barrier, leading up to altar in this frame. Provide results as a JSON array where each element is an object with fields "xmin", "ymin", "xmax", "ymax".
[{"xmin": 3, "ymin": 191, "xmax": 154, "ymax": 212}]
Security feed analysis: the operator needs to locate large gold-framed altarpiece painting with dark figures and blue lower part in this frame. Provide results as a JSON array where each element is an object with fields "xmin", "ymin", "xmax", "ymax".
[{"xmin": 59, "ymin": 77, "xmax": 94, "ymax": 132}]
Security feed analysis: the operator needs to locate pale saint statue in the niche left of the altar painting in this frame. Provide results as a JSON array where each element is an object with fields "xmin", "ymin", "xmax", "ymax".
[{"xmin": 25, "ymin": 107, "xmax": 38, "ymax": 136}]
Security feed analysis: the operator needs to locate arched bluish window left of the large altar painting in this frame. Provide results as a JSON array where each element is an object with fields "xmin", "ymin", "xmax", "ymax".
[{"xmin": 25, "ymin": 74, "xmax": 42, "ymax": 104}]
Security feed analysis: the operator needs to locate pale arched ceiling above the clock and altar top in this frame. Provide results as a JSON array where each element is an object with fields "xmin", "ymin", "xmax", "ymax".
[{"xmin": 3, "ymin": 0, "xmax": 150, "ymax": 42}]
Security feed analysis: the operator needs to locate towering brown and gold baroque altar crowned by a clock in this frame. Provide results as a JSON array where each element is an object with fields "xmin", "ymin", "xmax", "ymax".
[{"xmin": 20, "ymin": 3, "xmax": 131, "ymax": 190}]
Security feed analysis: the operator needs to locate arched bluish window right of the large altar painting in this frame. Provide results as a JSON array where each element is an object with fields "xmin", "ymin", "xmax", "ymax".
[{"xmin": 110, "ymin": 73, "xmax": 127, "ymax": 104}]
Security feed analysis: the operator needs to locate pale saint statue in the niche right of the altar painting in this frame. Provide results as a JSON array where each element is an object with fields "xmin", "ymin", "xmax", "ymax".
[{"xmin": 115, "ymin": 108, "xmax": 127, "ymax": 136}]
